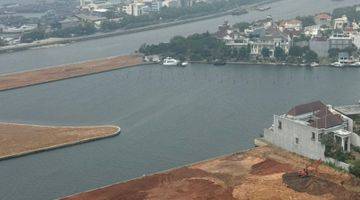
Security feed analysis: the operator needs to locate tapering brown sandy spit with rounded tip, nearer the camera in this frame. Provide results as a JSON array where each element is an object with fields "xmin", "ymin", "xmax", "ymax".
[{"xmin": 0, "ymin": 123, "xmax": 119, "ymax": 159}]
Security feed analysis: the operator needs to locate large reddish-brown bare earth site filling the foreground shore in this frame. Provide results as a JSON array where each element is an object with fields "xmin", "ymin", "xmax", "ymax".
[{"xmin": 64, "ymin": 146, "xmax": 360, "ymax": 200}]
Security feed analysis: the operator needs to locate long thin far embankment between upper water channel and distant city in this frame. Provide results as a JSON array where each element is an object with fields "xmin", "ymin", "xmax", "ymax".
[{"xmin": 0, "ymin": 0, "xmax": 282, "ymax": 54}]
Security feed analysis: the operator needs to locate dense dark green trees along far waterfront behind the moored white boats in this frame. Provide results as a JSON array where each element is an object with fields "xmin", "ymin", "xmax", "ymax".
[{"xmin": 139, "ymin": 32, "xmax": 318, "ymax": 63}]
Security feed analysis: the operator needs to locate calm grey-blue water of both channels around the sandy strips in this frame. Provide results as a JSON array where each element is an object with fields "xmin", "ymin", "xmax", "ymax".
[{"xmin": 0, "ymin": 0, "xmax": 360, "ymax": 200}]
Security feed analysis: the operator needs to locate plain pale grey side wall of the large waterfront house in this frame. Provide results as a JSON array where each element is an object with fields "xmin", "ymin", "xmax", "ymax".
[{"xmin": 264, "ymin": 115, "xmax": 325, "ymax": 160}]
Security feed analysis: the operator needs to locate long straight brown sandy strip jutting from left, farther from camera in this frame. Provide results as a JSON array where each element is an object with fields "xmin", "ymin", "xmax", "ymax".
[{"xmin": 0, "ymin": 55, "xmax": 142, "ymax": 91}]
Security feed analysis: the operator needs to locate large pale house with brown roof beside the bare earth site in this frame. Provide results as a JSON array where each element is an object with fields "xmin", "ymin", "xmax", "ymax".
[{"xmin": 264, "ymin": 101, "xmax": 359, "ymax": 160}]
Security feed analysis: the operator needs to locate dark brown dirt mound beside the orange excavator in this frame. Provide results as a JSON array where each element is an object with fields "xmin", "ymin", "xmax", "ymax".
[{"xmin": 282, "ymin": 172, "xmax": 360, "ymax": 199}]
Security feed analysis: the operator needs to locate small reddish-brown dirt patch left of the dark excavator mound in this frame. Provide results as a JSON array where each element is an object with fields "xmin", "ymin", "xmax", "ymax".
[{"xmin": 250, "ymin": 159, "xmax": 293, "ymax": 175}]
